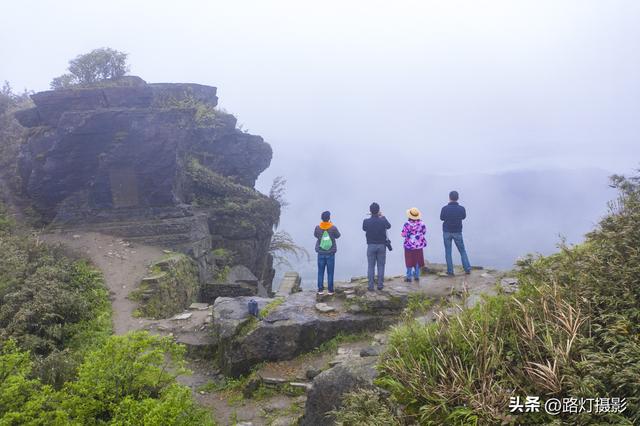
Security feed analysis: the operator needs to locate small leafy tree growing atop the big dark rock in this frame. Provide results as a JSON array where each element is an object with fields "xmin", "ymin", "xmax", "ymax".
[{"xmin": 51, "ymin": 47, "xmax": 129, "ymax": 89}]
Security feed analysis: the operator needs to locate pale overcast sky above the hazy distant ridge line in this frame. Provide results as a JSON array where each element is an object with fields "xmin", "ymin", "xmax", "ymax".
[{"xmin": 0, "ymin": 0, "xmax": 640, "ymax": 174}]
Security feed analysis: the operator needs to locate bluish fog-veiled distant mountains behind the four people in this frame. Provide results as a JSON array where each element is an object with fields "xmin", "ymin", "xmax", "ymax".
[{"xmin": 258, "ymin": 169, "xmax": 615, "ymax": 286}]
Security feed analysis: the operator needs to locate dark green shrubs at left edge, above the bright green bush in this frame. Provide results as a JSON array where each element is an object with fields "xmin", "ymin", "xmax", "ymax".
[{"xmin": 0, "ymin": 206, "xmax": 111, "ymax": 388}]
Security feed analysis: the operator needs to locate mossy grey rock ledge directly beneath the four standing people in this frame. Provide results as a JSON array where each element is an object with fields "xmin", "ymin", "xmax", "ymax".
[{"xmin": 210, "ymin": 270, "xmax": 508, "ymax": 376}]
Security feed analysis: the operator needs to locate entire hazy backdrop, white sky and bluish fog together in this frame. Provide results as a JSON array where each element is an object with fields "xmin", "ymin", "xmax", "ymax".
[{"xmin": 0, "ymin": 0, "xmax": 640, "ymax": 281}]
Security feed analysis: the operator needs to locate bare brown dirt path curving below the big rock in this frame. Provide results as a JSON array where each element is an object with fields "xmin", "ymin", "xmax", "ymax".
[{"xmin": 40, "ymin": 232, "xmax": 163, "ymax": 334}]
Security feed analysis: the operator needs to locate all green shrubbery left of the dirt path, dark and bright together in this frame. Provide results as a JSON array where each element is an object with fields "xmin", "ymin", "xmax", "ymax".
[{"xmin": 0, "ymin": 206, "xmax": 211, "ymax": 425}]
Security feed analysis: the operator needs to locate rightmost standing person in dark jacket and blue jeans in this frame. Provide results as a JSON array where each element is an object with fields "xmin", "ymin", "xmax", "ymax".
[{"xmin": 440, "ymin": 191, "xmax": 471, "ymax": 276}]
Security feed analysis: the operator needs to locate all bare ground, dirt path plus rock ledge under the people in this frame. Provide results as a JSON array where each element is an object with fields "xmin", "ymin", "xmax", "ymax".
[{"xmin": 41, "ymin": 232, "xmax": 517, "ymax": 425}]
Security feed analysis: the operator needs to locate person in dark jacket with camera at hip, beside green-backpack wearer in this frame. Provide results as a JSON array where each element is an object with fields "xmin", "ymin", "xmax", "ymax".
[{"xmin": 362, "ymin": 203, "xmax": 391, "ymax": 291}]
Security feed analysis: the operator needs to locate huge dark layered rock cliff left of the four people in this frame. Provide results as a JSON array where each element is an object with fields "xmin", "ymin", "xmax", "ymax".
[{"xmin": 16, "ymin": 77, "xmax": 280, "ymax": 290}]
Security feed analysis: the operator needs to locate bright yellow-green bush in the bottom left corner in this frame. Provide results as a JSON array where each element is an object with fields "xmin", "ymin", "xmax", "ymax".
[{"xmin": 0, "ymin": 332, "xmax": 212, "ymax": 425}]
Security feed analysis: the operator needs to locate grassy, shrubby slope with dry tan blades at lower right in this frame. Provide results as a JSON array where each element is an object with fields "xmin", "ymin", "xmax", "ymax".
[{"xmin": 338, "ymin": 171, "xmax": 640, "ymax": 425}]
